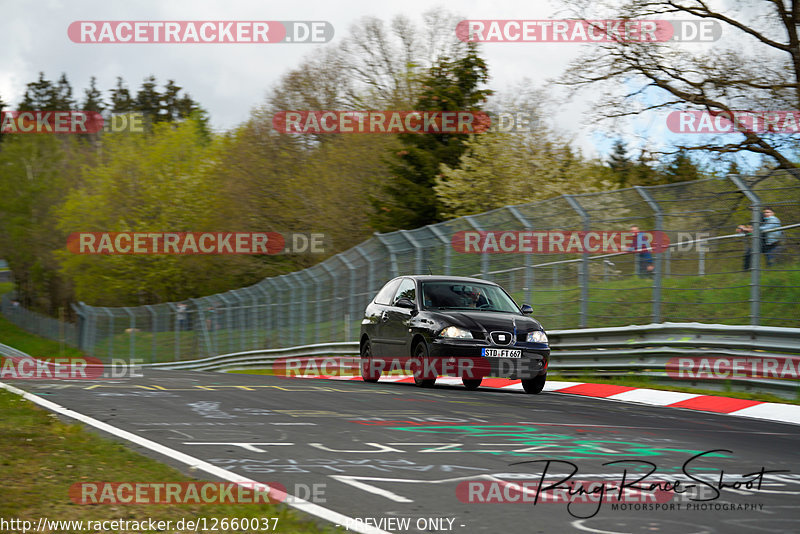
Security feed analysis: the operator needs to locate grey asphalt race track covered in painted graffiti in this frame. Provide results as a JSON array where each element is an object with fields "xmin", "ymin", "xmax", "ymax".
[{"xmin": 7, "ymin": 369, "xmax": 800, "ymax": 534}]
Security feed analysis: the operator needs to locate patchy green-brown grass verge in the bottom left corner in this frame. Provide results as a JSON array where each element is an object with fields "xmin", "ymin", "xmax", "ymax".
[{"xmin": 0, "ymin": 390, "xmax": 338, "ymax": 534}]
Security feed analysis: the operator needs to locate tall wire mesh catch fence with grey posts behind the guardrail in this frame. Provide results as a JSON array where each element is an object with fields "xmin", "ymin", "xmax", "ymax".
[{"xmin": 2, "ymin": 172, "xmax": 800, "ymax": 362}]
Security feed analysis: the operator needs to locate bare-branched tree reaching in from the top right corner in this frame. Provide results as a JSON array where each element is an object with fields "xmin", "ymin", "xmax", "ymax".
[{"xmin": 559, "ymin": 0, "xmax": 800, "ymax": 169}]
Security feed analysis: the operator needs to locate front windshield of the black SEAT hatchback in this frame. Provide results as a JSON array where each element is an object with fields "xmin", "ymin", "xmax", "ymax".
[{"xmin": 422, "ymin": 281, "xmax": 520, "ymax": 313}]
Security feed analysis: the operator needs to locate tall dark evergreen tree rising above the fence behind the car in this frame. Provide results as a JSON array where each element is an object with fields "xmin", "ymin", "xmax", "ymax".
[{"xmin": 372, "ymin": 43, "xmax": 491, "ymax": 231}]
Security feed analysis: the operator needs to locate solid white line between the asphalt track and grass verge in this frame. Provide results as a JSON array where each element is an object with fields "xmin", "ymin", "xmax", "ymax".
[{"xmin": 0, "ymin": 382, "xmax": 390, "ymax": 534}]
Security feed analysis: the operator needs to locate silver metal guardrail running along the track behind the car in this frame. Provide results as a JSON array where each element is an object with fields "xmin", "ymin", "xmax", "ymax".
[{"xmin": 139, "ymin": 323, "xmax": 800, "ymax": 397}]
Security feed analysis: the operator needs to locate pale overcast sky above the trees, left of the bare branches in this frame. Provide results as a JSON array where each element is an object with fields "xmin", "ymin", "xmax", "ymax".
[{"xmin": 0, "ymin": 0, "xmax": 760, "ymax": 168}]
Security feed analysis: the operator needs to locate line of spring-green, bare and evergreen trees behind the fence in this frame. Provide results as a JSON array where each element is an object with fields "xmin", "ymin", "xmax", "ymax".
[{"xmin": 0, "ymin": 12, "xmax": 702, "ymax": 313}]
